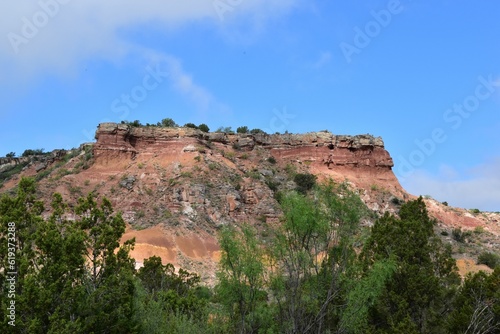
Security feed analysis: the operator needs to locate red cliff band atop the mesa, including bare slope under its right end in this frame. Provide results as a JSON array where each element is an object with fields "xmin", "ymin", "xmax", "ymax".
[{"xmin": 94, "ymin": 123, "xmax": 405, "ymax": 196}]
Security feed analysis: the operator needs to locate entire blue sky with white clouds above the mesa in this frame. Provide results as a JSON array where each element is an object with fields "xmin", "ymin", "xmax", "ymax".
[{"xmin": 0, "ymin": 0, "xmax": 500, "ymax": 211}]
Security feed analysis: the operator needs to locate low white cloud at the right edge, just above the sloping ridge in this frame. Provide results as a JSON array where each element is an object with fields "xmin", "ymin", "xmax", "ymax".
[{"xmin": 402, "ymin": 157, "xmax": 500, "ymax": 211}]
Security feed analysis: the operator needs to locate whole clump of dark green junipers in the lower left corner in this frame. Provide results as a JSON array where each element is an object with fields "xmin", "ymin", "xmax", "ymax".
[{"xmin": 0, "ymin": 179, "xmax": 139, "ymax": 333}]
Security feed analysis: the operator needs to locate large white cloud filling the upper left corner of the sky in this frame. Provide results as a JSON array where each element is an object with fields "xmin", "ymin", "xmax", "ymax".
[{"xmin": 0, "ymin": 0, "xmax": 298, "ymax": 80}]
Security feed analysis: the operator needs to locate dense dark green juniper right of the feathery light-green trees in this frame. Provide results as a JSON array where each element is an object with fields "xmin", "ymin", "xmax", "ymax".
[{"xmin": 362, "ymin": 197, "xmax": 460, "ymax": 333}]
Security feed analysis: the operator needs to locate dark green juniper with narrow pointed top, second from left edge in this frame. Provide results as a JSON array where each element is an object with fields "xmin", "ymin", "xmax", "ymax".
[{"xmin": 22, "ymin": 194, "xmax": 86, "ymax": 333}]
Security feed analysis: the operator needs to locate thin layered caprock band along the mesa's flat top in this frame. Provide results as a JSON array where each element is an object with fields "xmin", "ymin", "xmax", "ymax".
[{"xmin": 94, "ymin": 123, "xmax": 394, "ymax": 170}]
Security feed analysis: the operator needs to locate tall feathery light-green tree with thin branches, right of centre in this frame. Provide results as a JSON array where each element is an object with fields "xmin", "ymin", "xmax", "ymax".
[{"xmin": 270, "ymin": 183, "xmax": 365, "ymax": 333}]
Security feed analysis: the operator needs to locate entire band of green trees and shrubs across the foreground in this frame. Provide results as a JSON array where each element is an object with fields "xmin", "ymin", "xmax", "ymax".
[{"xmin": 0, "ymin": 174, "xmax": 500, "ymax": 334}]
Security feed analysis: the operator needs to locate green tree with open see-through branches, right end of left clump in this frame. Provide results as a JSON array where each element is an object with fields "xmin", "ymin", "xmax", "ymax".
[{"xmin": 75, "ymin": 193, "xmax": 136, "ymax": 333}]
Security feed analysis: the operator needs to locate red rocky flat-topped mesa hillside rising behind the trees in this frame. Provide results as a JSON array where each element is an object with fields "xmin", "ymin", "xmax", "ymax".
[{"xmin": 0, "ymin": 123, "xmax": 500, "ymax": 282}]
